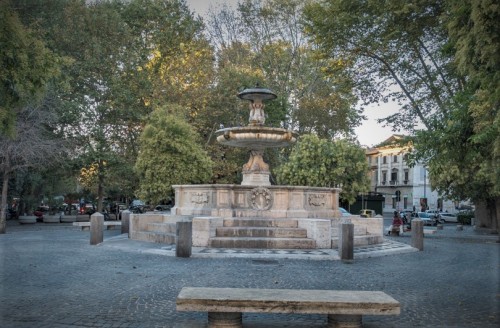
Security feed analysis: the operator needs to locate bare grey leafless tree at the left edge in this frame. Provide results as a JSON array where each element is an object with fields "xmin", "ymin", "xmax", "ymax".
[{"xmin": 0, "ymin": 102, "xmax": 65, "ymax": 233}]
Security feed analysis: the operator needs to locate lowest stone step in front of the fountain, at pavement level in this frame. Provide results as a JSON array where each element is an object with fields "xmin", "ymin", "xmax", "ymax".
[{"xmin": 209, "ymin": 237, "xmax": 316, "ymax": 249}]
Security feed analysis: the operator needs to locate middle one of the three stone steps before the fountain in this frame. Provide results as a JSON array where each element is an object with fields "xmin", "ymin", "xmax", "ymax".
[{"xmin": 215, "ymin": 227, "xmax": 307, "ymax": 238}]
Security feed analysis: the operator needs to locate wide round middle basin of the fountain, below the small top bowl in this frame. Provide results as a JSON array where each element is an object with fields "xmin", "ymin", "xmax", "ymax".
[{"xmin": 215, "ymin": 126, "xmax": 297, "ymax": 149}]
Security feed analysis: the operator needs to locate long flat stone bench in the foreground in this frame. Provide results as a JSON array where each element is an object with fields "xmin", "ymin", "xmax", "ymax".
[{"xmin": 177, "ymin": 287, "xmax": 401, "ymax": 327}]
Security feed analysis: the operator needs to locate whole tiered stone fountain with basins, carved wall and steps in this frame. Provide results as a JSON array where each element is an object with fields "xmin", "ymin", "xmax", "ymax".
[{"xmin": 130, "ymin": 87, "xmax": 383, "ymax": 249}]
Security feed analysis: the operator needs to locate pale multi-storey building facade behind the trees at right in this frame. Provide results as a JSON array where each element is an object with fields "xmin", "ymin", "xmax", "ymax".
[{"xmin": 366, "ymin": 135, "xmax": 455, "ymax": 213}]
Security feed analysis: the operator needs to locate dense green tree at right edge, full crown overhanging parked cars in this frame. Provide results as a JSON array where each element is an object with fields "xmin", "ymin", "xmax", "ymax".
[{"xmin": 415, "ymin": 1, "xmax": 500, "ymax": 232}]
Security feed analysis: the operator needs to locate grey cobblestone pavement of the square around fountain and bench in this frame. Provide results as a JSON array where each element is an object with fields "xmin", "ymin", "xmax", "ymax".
[{"xmin": 0, "ymin": 221, "xmax": 500, "ymax": 328}]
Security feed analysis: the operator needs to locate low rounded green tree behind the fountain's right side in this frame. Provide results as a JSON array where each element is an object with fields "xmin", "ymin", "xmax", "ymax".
[{"xmin": 276, "ymin": 134, "xmax": 370, "ymax": 204}]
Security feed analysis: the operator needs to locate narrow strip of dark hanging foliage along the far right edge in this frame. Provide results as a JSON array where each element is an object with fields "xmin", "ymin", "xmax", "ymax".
[{"xmin": 445, "ymin": 0, "xmax": 500, "ymax": 195}]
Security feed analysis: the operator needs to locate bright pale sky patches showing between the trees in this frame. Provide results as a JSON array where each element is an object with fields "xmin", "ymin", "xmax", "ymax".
[{"xmin": 186, "ymin": 0, "xmax": 397, "ymax": 147}]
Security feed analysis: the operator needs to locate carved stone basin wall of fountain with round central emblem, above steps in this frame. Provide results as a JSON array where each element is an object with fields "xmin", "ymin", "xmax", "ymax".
[{"xmin": 171, "ymin": 183, "xmax": 341, "ymax": 218}]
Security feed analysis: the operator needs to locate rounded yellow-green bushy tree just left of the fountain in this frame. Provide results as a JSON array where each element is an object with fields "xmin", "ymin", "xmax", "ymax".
[{"xmin": 135, "ymin": 105, "xmax": 213, "ymax": 203}]
